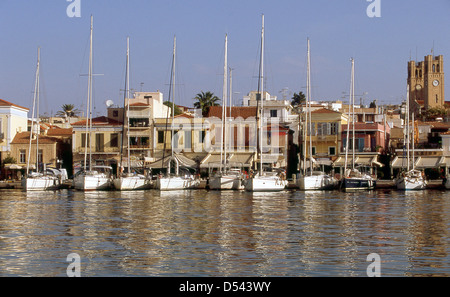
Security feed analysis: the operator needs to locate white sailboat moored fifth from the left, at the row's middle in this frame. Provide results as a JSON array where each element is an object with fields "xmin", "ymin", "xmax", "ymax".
[{"xmin": 209, "ymin": 35, "xmax": 241, "ymax": 190}]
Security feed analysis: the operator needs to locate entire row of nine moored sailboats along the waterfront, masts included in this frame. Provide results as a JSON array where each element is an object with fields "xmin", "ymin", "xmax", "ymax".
[{"xmin": 23, "ymin": 15, "xmax": 426, "ymax": 191}]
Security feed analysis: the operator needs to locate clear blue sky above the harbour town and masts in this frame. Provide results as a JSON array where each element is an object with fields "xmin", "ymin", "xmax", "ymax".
[{"xmin": 0, "ymin": 0, "xmax": 450, "ymax": 116}]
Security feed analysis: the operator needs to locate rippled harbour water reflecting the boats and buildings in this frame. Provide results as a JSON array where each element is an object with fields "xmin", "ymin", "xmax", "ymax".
[{"xmin": 0, "ymin": 190, "xmax": 450, "ymax": 276}]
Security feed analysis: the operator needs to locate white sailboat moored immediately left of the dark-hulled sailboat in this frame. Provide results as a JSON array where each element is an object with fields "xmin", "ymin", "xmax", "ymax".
[{"xmin": 297, "ymin": 38, "xmax": 338, "ymax": 190}]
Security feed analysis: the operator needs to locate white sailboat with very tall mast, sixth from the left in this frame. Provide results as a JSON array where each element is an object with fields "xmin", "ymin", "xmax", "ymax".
[{"xmin": 244, "ymin": 15, "xmax": 287, "ymax": 192}]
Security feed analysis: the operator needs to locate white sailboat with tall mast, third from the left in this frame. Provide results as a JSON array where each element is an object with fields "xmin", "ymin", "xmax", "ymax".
[{"xmin": 113, "ymin": 37, "xmax": 151, "ymax": 191}]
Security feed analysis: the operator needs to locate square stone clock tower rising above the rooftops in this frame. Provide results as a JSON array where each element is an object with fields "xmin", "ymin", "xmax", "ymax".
[{"xmin": 408, "ymin": 55, "xmax": 445, "ymax": 114}]
